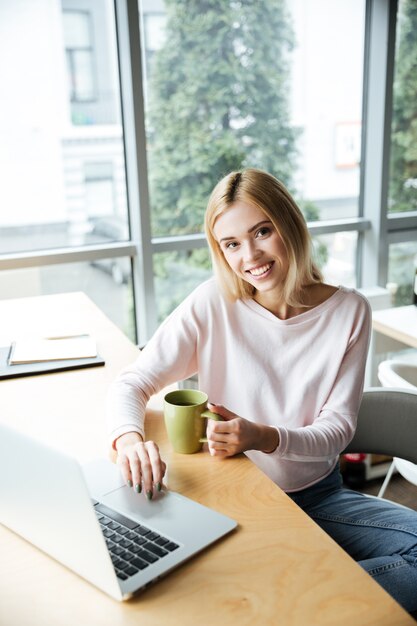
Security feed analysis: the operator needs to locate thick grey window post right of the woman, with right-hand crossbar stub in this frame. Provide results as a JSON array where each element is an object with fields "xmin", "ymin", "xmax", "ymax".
[{"xmin": 357, "ymin": 0, "xmax": 417, "ymax": 288}]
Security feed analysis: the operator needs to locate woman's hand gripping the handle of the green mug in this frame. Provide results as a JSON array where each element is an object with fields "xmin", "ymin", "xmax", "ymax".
[{"xmin": 207, "ymin": 404, "xmax": 279, "ymax": 457}]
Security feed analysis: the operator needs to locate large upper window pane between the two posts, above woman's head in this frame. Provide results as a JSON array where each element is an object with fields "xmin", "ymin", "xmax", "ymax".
[{"xmin": 142, "ymin": 0, "xmax": 365, "ymax": 235}]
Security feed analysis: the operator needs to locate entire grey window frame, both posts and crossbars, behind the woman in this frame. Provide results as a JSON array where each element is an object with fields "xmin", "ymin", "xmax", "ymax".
[{"xmin": 0, "ymin": 0, "xmax": 417, "ymax": 344}]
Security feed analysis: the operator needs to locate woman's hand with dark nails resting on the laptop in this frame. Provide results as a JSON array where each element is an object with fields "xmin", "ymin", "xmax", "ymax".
[{"xmin": 115, "ymin": 432, "xmax": 166, "ymax": 500}]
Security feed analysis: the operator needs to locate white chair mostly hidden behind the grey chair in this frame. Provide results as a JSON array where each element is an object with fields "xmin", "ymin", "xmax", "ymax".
[{"xmin": 378, "ymin": 360, "xmax": 417, "ymax": 498}]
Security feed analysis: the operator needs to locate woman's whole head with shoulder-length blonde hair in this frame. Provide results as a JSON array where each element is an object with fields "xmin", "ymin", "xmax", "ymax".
[{"xmin": 204, "ymin": 168, "xmax": 323, "ymax": 310}]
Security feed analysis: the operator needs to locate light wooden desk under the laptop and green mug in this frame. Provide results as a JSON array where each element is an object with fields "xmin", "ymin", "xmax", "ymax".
[{"xmin": 0, "ymin": 294, "xmax": 414, "ymax": 626}]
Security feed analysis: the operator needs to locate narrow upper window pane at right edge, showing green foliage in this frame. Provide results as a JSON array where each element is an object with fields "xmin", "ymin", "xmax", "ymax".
[{"xmin": 388, "ymin": 0, "xmax": 417, "ymax": 213}]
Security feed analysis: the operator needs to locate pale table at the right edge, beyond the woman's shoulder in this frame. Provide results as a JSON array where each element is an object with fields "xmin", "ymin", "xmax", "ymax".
[{"xmin": 372, "ymin": 304, "xmax": 417, "ymax": 348}]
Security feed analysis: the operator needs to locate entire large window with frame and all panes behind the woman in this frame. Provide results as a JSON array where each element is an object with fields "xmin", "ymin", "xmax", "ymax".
[{"xmin": 0, "ymin": 0, "xmax": 417, "ymax": 343}]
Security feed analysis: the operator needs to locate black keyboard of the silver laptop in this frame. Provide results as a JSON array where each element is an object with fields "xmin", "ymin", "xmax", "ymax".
[{"xmin": 93, "ymin": 500, "xmax": 179, "ymax": 580}]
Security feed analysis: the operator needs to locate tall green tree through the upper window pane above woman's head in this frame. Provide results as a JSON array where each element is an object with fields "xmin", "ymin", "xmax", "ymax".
[{"xmin": 148, "ymin": 0, "xmax": 297, "ymax": 235}]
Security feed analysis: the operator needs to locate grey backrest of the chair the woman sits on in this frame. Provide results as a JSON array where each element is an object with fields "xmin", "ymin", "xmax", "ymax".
[{"xmin": 343, "ymin": 387, "xmax": 417, "ymax": 463}]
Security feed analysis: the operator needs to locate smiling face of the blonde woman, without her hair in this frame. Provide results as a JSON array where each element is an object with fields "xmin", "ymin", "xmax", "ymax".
[{"xmin": 213, "ymin": 201, "xmax": 288, "ymax": 304}]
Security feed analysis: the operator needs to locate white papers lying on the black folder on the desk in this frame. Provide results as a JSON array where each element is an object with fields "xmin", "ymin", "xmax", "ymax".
[{"xmin": 9, "ymin": 335, "xmax": 97, "ymax": 365}]
